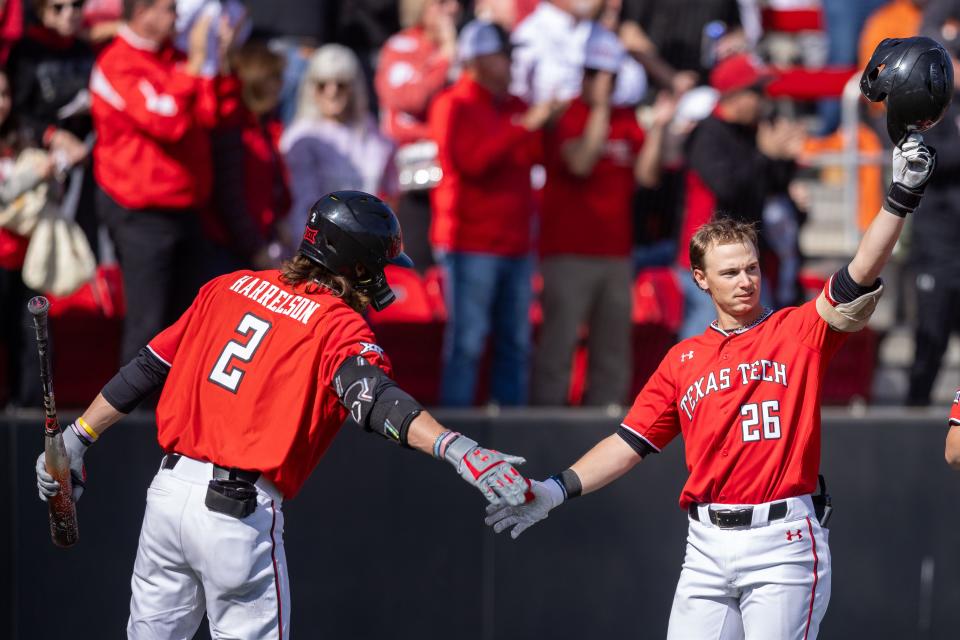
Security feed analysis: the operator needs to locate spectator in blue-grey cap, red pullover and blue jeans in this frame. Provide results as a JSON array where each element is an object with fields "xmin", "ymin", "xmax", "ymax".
[{"xmin": 429, "ymin": 20, "xmax": 556, "ymax": 406}]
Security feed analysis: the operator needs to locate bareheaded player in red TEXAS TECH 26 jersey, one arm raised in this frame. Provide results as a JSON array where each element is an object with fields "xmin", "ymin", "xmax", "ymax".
[{"xmin": 487, "ymin": 134, "xmax": 934, "ymax": 640}]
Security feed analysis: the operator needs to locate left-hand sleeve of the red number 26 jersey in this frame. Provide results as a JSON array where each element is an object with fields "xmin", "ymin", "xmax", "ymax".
[{"xmin": 622, "ymin": 355, "xmax": 680, "ymax": 452}]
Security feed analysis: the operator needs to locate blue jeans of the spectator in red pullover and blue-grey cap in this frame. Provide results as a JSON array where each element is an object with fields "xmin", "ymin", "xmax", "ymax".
[{"xmin": 438, "ymin": 252, "xmax": 533, "ymax": 407}]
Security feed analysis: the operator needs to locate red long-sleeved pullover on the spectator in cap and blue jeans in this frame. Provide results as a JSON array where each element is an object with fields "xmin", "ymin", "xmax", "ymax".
[{"xmin": 430, "ymin": 74, "xmax": 541, "ymax": 256}]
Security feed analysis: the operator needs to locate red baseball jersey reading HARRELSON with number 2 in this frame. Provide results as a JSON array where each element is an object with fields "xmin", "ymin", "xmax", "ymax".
[{"xmin": 148, "ymin": 270, "xmax": 390, "ymax": 498}]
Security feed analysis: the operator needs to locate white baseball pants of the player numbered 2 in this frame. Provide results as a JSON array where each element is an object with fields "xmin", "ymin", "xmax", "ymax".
[{"xmin": 127, "ymin": 457, "xmax": 290, "ymax": 640}]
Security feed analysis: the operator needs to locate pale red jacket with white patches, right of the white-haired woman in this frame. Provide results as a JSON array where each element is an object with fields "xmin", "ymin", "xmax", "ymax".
[{"xmin": 374, "ymin": 27, "xmax": 450, "ymax": 145}]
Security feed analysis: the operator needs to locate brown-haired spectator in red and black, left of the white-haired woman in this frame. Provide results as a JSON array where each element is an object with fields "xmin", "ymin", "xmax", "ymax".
[{"xmin": 204, "ymin": 41, "xmax": 290, "ymax": 275}]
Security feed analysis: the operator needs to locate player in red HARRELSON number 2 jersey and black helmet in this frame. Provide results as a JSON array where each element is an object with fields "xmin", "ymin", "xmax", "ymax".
[{"xmin": 37, "ymin": 191, "xmax": 528, "ymax": 639}]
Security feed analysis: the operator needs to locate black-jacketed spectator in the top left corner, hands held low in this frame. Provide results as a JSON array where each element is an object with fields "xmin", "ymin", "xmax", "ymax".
[{"xmin": 8, "ymin": 0, "xmax": 99, "ymax": 248}]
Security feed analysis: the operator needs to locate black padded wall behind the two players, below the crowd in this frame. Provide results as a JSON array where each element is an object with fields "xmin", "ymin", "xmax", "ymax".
[{"xmin": 0, "ymin": 410, "xmax": 960, "ymax": 640}]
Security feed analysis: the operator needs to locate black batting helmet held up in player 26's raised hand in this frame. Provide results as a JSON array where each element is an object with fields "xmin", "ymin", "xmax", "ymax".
[{"xmin": 860, "ymin": 36, "xmax": 953, "ymax": 145}]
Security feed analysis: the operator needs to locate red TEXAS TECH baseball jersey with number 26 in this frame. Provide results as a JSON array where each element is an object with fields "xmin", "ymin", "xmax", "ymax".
[{"xmin": 623, "ymin": 301, "xmax": 847, "ymax": 509}]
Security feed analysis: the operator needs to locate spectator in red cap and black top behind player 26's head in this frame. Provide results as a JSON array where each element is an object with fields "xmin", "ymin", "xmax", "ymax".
[{"xmin": 677, "ymin": 54, "xmax": 803, "ymax": 340}]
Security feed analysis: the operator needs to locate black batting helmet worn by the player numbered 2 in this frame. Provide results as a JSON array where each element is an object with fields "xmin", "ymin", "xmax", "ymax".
[{"xmin": 300, "ymin": 191, "xmax": 413, "ymax": 311}]
